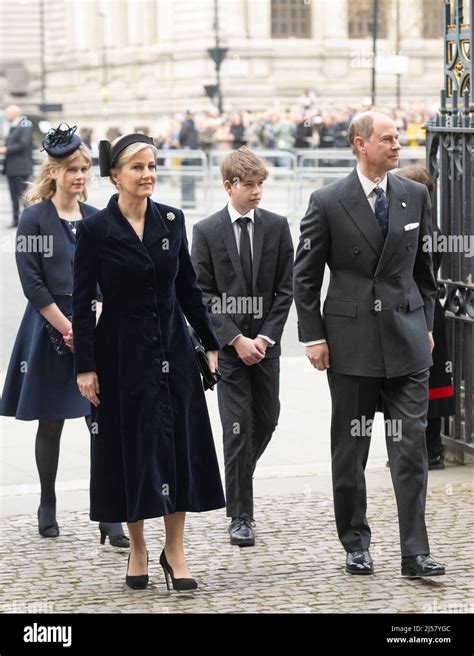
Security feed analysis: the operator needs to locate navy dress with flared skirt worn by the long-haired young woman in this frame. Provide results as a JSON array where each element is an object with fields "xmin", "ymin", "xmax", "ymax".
[{"xmin": 0, "ymin": 219, "xmax": 90, "ymax": 421}]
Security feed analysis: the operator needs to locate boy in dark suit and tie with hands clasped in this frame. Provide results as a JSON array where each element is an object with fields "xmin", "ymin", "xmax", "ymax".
[{"xmin": 192, "ymin": 146, "xmax": 293, "ymax": 547}]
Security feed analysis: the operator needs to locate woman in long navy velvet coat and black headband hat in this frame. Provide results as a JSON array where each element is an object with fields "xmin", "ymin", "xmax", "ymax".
[{"xmin": 73, "ymin": 135, "xmax": 225, "ymax": 589}]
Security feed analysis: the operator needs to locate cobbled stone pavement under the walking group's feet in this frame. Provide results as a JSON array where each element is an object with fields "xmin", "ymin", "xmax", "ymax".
[{"xmin": 0, "ymin": 466, "xmax": 474, "ymax": 613}]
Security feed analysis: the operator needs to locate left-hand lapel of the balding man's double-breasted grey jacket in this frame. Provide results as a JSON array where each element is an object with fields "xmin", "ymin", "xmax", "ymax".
[{"xmin": 339, "ymin": 169, "xmax": 384, "ymax": 256}]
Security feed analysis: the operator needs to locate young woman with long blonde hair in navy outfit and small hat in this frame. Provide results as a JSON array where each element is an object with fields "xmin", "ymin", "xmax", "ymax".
[{"xmin": 0, "ymin": 125, "xmax": 129, "ymax": 547}]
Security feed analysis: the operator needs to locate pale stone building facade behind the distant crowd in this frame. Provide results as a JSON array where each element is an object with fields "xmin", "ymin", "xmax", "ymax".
[{"xmin": 0, "ymin": 0, "xmax": 444, "ymax": 129}]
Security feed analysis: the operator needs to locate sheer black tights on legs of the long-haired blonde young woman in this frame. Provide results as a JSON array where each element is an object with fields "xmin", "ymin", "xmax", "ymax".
[{"xmin": 35, "ymin": 416, "xmax": 91, "ymax": 505}]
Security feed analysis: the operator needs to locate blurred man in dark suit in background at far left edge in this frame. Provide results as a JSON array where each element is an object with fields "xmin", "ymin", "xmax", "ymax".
[{"xmin": 0, "ymin": 105, "xmax": 33, "ymax": 228}]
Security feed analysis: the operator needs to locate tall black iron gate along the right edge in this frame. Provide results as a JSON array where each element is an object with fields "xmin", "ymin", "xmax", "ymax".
[{"xmin": 426, "ymin": 0, "xmax": 474, "ymax": 453}]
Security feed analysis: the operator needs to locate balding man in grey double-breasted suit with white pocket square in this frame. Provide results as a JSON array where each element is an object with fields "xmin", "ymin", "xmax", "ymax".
[{"xmin": 294, "ymin": 111, "xmax": 445, "ymax": 576}]
